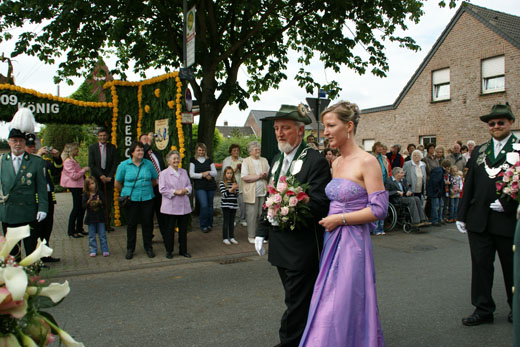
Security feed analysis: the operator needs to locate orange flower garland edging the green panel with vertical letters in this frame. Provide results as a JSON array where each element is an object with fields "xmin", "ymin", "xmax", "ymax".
[{"xmin": 103, "ymin": 71, "xmax": 186, "ymax": 226}]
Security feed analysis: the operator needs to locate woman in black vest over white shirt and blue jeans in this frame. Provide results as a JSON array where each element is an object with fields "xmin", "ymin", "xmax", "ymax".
[{"xmin": 190, "ymin": 142, "xmax": 217, "ymax": 233}]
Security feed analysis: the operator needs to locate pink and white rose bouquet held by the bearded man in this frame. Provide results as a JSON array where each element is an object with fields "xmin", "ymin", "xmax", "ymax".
[{"xmin": 263, "ymin": 176, "xmax": 310, "ymax": 231}]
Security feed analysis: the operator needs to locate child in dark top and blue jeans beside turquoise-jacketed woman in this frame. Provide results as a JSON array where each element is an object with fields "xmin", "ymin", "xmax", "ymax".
[{"xmin": 82, "ymin": 176, "xmax": 110, "ymax": 257}]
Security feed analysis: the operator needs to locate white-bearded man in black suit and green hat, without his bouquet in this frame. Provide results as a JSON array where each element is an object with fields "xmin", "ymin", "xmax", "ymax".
[{"xmin": 255, "ymin": 105, "xmax": 331, "ymax": 346}]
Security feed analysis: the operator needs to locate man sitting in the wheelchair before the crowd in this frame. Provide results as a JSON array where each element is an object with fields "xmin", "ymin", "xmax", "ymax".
[{"xmin": 385, "ymin": 166, "xmax": 429, "ymax": 228}]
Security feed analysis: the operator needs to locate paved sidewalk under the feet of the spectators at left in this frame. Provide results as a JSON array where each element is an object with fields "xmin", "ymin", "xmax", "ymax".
[{"xmin": 48, "ymin": 193, "xmax": 256, "ymax": 277}]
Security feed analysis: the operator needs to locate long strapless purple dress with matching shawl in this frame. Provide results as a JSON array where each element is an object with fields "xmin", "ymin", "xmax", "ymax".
[{"xmin": 300, "ymin": 178, "xmax": 388, "ymax": 347}]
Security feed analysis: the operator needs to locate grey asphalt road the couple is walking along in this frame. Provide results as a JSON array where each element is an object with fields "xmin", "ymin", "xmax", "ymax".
[{"xmin": 50, "ymin": 225, "xmax": 512, "ymax": 347}]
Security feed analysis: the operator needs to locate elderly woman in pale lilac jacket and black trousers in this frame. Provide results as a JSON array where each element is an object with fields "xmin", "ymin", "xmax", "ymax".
[{"xmin": 159, "ymin": 151, "xmax": 191, "ymax": 259}]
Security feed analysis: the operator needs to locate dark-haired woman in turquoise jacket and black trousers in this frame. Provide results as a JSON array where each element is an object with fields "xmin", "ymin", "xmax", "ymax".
[{"xmin": 115, "ymin": 142, "xmax": 158, "ymax": 260}]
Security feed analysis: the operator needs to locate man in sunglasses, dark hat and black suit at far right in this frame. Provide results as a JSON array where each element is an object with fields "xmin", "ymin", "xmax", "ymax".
[{"xmin": 457, "ymin": 104, "xmax": 520, "ymax": 326}]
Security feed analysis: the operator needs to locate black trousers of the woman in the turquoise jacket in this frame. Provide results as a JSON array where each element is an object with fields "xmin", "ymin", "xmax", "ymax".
[{"xmin": 126, "ymin": 199, "xmax": 153, "ymax": 252}]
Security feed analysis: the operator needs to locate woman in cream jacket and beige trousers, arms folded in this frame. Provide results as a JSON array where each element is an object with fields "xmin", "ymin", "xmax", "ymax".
[{"xmin": 241, "ymin": 141, "xmax": 269, "ymax": 243}]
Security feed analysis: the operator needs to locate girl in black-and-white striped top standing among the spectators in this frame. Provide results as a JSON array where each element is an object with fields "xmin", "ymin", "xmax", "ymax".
[{"xmin": 219, "ymin": 166, "xmax": 238, "ymax": 246}]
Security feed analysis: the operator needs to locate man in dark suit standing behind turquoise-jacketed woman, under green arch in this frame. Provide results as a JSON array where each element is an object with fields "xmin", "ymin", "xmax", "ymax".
[{"xmin": 88, "ymin": 128, "xmax": 119, "ymax": 231}]
